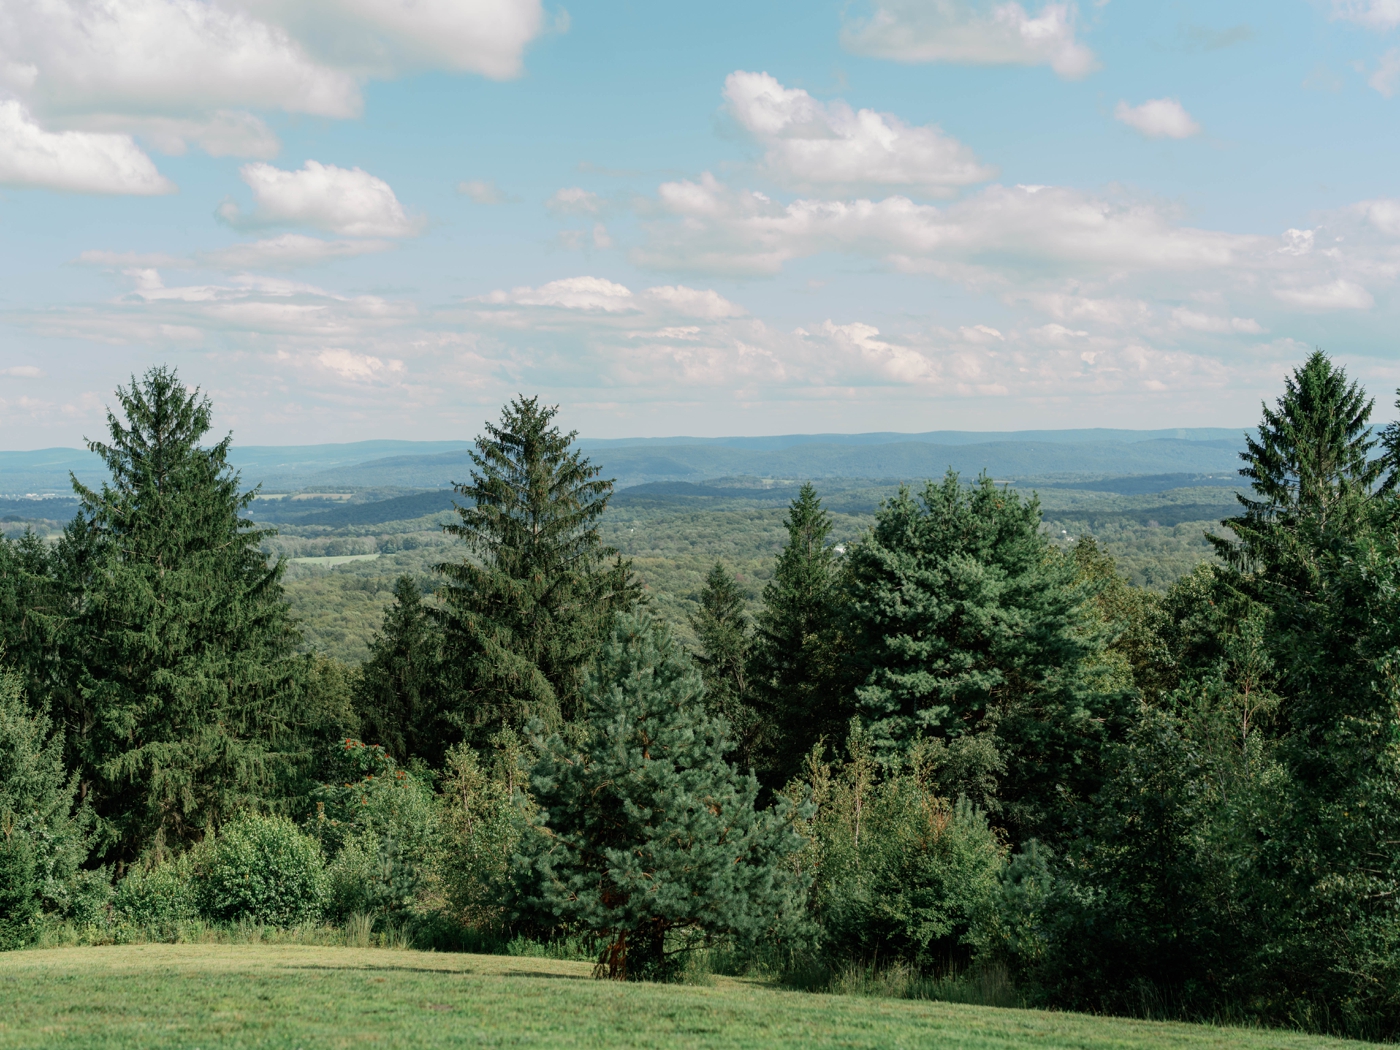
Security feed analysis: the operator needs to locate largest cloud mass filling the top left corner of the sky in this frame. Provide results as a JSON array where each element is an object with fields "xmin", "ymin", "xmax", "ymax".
[{"xmin": 0, "ymin": 0, "xmax": 545, "ymax": 172}]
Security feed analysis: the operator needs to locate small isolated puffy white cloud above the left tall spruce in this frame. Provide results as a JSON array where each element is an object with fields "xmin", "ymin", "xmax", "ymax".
[{"xmin": 218, "ymin": 161, "xmax": 421, "ymax": 237}]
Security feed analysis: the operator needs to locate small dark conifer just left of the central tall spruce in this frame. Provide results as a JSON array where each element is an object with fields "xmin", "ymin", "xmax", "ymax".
[{"xmin": 354, "ymin": 575, "xmax": 445, "ymax": 767}]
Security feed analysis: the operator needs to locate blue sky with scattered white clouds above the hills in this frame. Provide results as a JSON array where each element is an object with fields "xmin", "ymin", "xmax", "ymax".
[{"xmin": 0, "ymin": 0, "xmax": 1400, "ymax": 449}]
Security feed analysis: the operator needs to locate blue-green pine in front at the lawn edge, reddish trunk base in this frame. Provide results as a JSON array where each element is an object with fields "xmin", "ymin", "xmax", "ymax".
[{"xmin": 518, "ymin": 615, "xmax": 805, "ymax": 979}]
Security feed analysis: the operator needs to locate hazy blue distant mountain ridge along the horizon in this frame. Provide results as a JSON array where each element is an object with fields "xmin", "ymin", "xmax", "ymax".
[{"xmin": 0, "ymin": 427, "xmax": 1245, "ymax": 496}]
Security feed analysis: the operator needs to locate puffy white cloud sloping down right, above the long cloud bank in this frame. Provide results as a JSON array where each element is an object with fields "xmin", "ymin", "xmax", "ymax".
[{"xmin": 724, "ymin": 70, "xmax": 997, "ymax": 196}]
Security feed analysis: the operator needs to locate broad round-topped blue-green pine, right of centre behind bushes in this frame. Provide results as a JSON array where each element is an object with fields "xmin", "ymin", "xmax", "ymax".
[{"xmin": 850, "ymin": 470, "xmax": 1130, "ymax": 837}]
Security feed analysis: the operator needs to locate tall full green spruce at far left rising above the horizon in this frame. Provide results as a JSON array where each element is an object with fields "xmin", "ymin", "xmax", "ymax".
[{"xmin": 60, "ymin": 367, "xmax": 304, "ymax": 861}]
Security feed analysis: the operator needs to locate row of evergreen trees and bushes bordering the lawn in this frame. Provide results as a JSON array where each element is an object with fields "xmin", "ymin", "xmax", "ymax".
[{"xmin": 0, "ymin": 353, "xmax": 1400, "ymax": 1037}]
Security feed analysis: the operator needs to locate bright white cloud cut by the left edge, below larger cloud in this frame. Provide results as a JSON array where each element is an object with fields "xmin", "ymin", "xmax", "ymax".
[{"xmin": 0, "ymin": 99, "xmax": 175, "ymax": 196}]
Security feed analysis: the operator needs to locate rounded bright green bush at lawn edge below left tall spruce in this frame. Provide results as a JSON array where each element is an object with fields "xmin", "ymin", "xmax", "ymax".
[{"xmin": 195, "ymin": 816, "xmax": 328, "ymax": 927}]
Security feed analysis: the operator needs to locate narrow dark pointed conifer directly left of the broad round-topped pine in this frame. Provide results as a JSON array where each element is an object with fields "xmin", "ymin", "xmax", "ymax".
[{"xmin": 749, "ymin": 484, "xmax": 851, "ymax": 787}]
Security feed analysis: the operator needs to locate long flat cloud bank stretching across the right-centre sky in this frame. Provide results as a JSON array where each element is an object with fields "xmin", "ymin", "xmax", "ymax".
[{"xmin": 634, "ymin": 172, "xmax": 1261, "ymax": 279}]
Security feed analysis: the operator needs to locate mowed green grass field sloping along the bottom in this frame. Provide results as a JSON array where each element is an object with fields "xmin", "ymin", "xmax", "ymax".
[{"xmin": 0, "ymin": 945, "xmax": 1362, "ymax": 1050}]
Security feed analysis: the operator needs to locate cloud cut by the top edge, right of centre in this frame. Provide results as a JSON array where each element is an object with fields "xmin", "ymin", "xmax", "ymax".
[{"xmin": 841, "ymin": 0, "xmax": 1098, "ymax": 80}]
